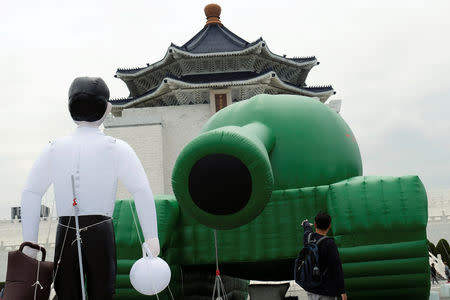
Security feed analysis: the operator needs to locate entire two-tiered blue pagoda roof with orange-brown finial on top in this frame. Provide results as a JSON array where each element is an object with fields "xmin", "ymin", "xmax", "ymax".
[{"xmin": 111, "ymin": 4, "xmax": 334, "ymax": 105}]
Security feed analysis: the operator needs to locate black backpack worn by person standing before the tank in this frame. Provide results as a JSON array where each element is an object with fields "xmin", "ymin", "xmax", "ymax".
[{"xmin": 294, "ymin": 232, "xmax": 329, "ymax": 290}]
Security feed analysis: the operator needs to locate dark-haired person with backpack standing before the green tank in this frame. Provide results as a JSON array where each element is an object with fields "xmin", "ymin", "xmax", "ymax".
[{"xmin": 295, "ymin": 212, "xmax": 347, "ymax": 300}]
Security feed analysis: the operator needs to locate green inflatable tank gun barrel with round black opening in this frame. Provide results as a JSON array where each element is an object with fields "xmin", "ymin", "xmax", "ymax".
[{"xmin": 172, "ymin": 122, "xmax": 275, "ymax": 229}]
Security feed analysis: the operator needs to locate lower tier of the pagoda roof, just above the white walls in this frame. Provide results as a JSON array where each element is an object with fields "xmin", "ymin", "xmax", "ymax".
[{"xmin": 110, "ymin": 71, "xmax": 335, "ymax": 111}]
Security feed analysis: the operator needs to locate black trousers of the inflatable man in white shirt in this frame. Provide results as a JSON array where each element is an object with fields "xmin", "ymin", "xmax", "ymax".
[{"xmin": 55, "ymin": 215, "xmax": 117, "ymax": 300}]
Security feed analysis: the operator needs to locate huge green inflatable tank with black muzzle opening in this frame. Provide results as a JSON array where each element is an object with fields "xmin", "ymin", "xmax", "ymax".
[{"xmin": 115, "ymin": 95, "xmax": 430, "ymax": 299}]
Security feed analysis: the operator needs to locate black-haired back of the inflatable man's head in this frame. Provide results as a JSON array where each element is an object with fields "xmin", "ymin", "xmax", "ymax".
[{"xmin": 69, "ymin": 77, "xmax": 109, "ymax": 122}]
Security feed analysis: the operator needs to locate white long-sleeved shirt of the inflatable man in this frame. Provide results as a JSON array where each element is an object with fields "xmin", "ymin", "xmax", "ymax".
[{"xmin": 21, "ymin": 126, "xmax": 158, "ymax": 241}]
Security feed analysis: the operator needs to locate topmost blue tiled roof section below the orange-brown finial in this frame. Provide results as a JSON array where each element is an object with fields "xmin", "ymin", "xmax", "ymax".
[{"xmin": 175, "ymin": 24, "xmax": 260, "ymax": 53}]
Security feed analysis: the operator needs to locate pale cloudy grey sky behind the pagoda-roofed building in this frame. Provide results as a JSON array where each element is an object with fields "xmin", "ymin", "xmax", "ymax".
[{"xmin": 0, "ymin": 0, "xmax": 450, "ymax": 219}]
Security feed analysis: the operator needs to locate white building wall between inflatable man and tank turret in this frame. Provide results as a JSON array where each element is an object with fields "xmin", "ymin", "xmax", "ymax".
[{"xmin": 104, "ymin": 104, "xmax": 212, "ymax": 199}]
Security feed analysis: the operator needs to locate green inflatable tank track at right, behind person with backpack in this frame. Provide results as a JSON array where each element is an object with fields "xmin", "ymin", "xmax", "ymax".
[{"xmin": 327, "ymin": 176, "xmax": 430, "ymax": 299}]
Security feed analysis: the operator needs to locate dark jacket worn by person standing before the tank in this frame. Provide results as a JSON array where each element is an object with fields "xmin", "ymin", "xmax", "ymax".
[{"xmin": 303, "ymin": 222, "xmax": 345, "ymax": 297}]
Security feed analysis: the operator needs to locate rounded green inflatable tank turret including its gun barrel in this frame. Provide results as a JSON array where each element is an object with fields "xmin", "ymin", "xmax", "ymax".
[{"xmin": 172, "ymin": 95, "xmax": 362, "ymax": 229}]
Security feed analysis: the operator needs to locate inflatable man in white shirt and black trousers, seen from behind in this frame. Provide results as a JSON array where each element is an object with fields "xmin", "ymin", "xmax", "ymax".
[{"xmin": 22, "ymin": 77, "xmax": 160, "ymax": 300}]
